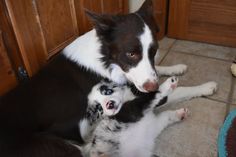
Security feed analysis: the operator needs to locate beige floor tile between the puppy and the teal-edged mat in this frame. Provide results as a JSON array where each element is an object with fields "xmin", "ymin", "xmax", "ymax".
[{"xmin": 155, "ymin": 98, "xmax": 226, "ymax": 157}]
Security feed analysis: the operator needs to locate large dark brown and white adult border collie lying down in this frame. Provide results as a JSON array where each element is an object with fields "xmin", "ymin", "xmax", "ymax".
[{"xmin": 0, "ymin": 0, "xmax": 216, "ymax": 157}]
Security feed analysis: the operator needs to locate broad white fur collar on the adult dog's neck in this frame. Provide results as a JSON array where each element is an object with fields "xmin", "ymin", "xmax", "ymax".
[{"xmin": 63, "ymin": 29, "xmax": 114, "ymax": 81}]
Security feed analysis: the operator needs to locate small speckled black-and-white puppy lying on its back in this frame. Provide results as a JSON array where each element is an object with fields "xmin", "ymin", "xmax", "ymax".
[{"xmin": 80, "ymin": 77, "xmax": 188, "ymax": 157}]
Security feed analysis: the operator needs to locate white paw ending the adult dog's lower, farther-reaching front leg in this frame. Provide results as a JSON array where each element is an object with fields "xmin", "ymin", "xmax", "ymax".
[{"xmin": 200, "ymin": 81, "xmax": 217, "ymax": 96}]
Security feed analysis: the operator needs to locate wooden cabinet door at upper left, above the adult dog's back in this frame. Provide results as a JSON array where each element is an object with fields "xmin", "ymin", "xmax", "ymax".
[{"xmin": 5, "ymin": 0, "xmax": 78, "ymax": 76}]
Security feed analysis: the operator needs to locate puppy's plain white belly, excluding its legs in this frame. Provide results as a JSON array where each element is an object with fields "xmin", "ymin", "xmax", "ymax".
[{"xmin": 120, "ymin": 112, "xmax": 158, "ymax": 157}]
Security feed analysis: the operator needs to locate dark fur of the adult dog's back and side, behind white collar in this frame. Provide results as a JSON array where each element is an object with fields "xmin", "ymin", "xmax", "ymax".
[{"xmin": 0, "ymin": 55, "xmax": 98, "ymax": 157}]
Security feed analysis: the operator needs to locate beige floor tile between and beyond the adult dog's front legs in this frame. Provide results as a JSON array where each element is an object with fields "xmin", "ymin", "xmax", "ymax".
[{"xmin": 161, "ymin": 51, "xmax": 232, "ymax": 102}]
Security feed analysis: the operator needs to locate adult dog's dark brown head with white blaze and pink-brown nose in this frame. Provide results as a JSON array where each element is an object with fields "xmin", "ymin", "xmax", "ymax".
[{"xmin": 87, "ymin": 0, "xmax": 158, "ymax": 92}]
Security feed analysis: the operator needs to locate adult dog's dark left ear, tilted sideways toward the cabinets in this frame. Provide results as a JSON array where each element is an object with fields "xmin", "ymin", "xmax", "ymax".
[{"xmin": 85, "ymin": 9, "xmax": 115, "ymax": 33}]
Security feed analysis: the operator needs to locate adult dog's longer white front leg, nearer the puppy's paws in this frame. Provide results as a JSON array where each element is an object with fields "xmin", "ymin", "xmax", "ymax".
[{"xmin": 167, "ymin": 81, "xmax": 217, "ymax": 104}]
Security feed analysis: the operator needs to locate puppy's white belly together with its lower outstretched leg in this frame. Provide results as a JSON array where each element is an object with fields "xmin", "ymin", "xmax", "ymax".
[{"xmin": 120, "ymin": 108, "xmax": 188, "ymax": 157}]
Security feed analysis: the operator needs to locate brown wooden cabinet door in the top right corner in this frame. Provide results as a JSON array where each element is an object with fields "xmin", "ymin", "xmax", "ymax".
[{"xmin": 168, "ymin": 0, "xmax": 236, "ymax": 47}]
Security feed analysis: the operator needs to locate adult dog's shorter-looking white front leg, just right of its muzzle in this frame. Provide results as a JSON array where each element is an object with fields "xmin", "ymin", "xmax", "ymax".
[{"xmin": 155, "ymin": 64, "xmax": 187, "ymax": 76}]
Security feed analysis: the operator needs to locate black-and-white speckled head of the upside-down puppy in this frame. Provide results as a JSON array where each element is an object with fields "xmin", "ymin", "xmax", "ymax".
[{"xmin": 88, "ymin": 82, "xmax": 127, "ymax": 116}]
